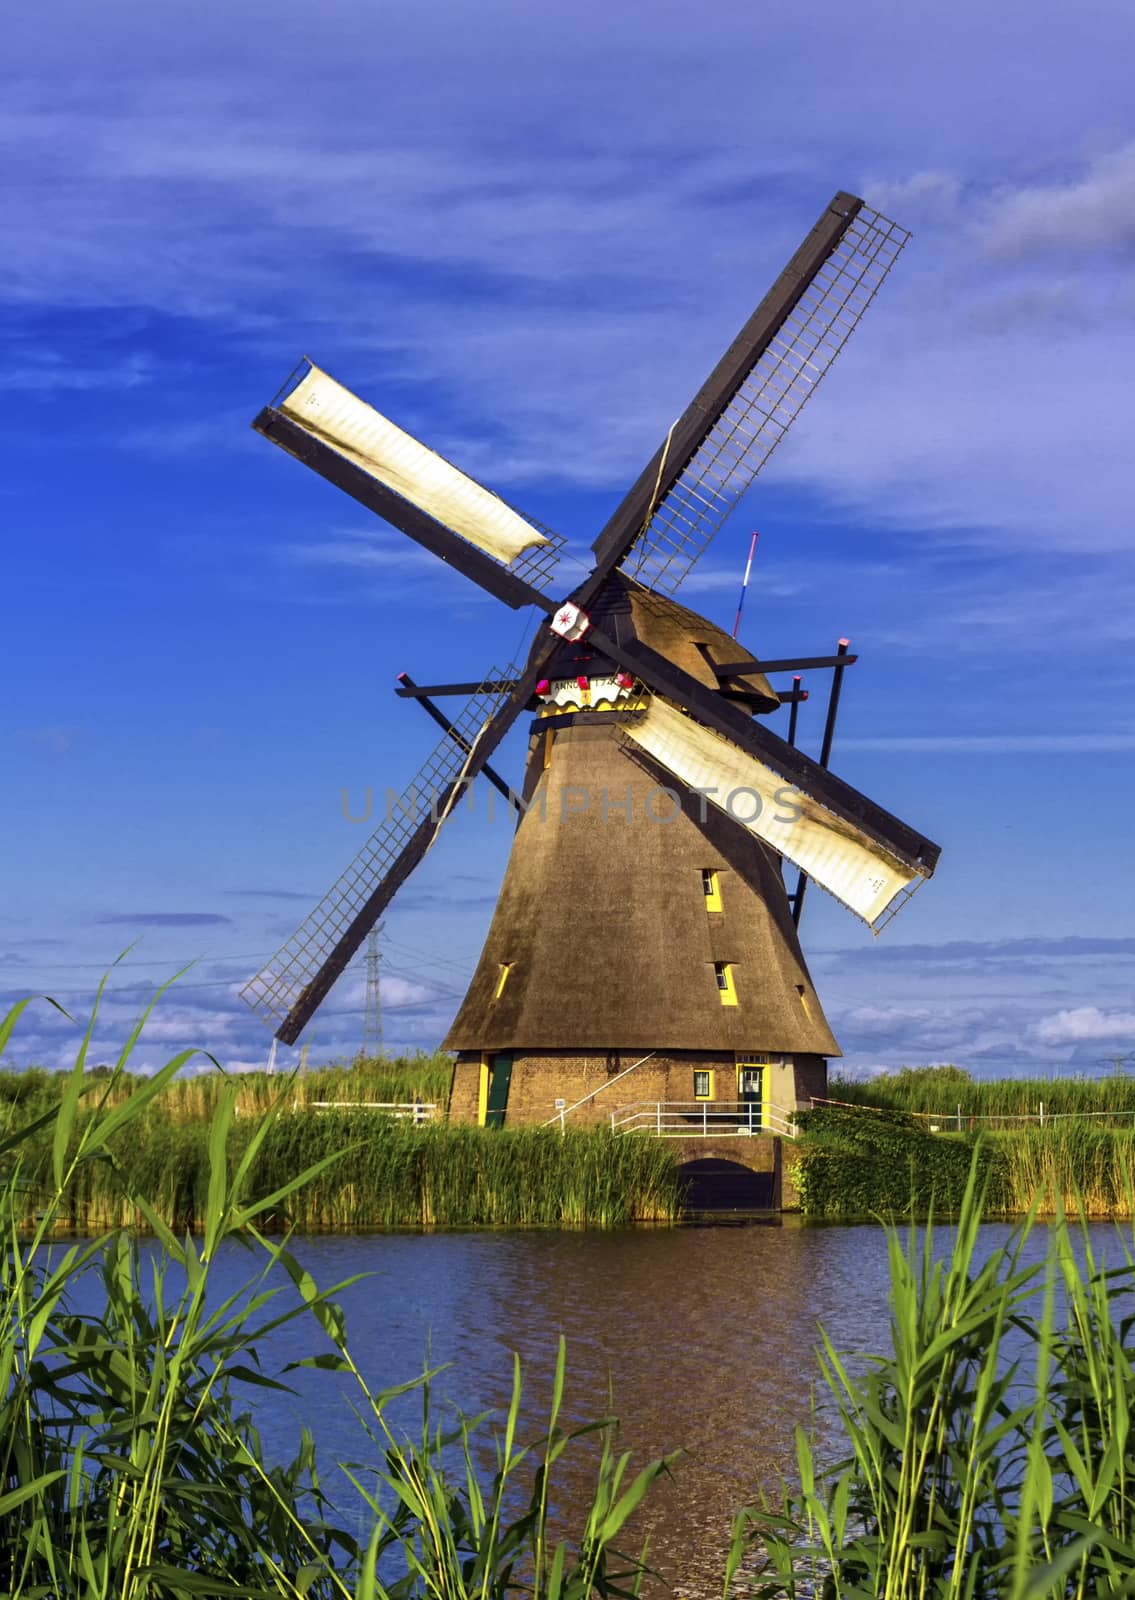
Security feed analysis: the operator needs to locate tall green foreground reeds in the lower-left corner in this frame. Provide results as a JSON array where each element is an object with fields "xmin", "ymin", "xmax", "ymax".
[{"xmin": 0, "ymin": 985, "xmax": 666, "ymax": 1600}]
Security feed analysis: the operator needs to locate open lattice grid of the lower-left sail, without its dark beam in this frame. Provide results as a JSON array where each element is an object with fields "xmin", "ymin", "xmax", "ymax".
[{"xmin": 240, "ymin": 666, "xmax": 520, "ymax": 1030}]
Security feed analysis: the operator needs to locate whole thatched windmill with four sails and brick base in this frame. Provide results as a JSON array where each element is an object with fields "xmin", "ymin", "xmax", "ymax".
[{"xmin": 242, "ymin": 192, "xmax": 938, "ymax": 1125}]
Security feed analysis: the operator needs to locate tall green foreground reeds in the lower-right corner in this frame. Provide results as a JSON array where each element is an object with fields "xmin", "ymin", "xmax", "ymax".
[{"xmin": 727, "ymin": 1168, "xmax": 1135, "ymax": 1600}]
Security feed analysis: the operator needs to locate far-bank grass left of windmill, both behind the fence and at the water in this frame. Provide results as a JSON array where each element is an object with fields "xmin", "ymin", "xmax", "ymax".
[{"xmin": 0, "ymin": 1036, "xmax": 680, "ymax": 1230}]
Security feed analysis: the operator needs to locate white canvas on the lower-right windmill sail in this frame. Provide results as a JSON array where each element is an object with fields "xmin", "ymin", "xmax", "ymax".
[{"xmin": 624, "ymin": 698, "xmax": 920, "ymax": 925}]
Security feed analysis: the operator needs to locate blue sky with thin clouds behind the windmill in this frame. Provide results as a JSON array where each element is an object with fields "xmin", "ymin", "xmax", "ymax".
[{"xmin": 0, "ymin": 0, "xmax": 1135, "ymax": 1072}]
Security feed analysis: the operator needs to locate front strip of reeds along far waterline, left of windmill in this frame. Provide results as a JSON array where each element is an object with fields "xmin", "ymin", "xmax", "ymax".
[{"xmin": 8, "ymin": 1113, "xmax": 680, "ymax": 1232}]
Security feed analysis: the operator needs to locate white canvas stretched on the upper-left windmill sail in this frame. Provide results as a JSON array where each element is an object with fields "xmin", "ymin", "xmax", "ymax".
[{"xmin": 279, "ymin": 366, "xmax": 549, "ymax": 565}]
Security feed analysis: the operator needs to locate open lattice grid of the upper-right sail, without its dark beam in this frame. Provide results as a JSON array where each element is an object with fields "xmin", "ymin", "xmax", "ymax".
[{"xmin": 623, "ymin": 206, "xmax": 911, "ymax": 594}]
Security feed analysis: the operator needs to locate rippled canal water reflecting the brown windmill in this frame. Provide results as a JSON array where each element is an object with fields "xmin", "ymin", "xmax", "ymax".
[{"xmin": 203, "ymin": 1218, "xmax": 1062, "ymax": 1595}]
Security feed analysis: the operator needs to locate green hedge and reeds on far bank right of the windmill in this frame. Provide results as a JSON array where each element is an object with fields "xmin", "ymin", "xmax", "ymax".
[{"xmin": 796, "ymin": 1106, "xmax": 1135, "ymax": 1218}]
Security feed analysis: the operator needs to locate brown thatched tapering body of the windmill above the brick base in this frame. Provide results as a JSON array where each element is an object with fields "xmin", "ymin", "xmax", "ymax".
[{"xmin": 445, "ymin": 726, "xmax": 839, "ymax": 1056}]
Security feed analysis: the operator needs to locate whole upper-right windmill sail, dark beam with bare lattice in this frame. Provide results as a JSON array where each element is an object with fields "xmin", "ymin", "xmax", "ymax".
[{"xmin": 594, "ymin": 194, "xmax": 909, "ymax": 594}]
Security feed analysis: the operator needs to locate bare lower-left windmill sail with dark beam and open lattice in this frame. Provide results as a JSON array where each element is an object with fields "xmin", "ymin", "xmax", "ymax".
[{"xmin": 240, "ymin": 667, "xmax": 519, "ymax": 1045}]
